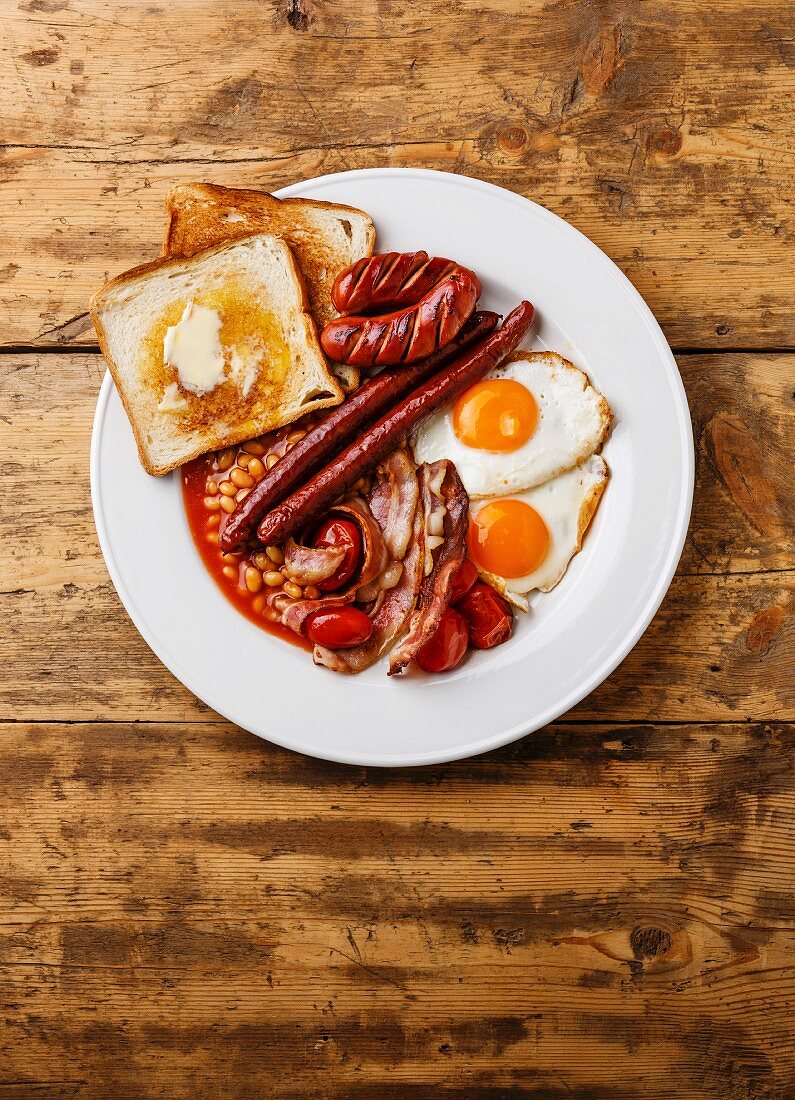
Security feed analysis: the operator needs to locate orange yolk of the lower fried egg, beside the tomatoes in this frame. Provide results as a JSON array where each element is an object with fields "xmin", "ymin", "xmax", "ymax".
[{"xmin": 468, "ymin": 498, "xmax": 550, "ymax": 578}]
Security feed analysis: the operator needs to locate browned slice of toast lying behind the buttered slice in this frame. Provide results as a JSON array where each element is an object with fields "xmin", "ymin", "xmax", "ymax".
[{"xmin": 163, "ymin": 184, "xmax": 375, "ymax": 391}]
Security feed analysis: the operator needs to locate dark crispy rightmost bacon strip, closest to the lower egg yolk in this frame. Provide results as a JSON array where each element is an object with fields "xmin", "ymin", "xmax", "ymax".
[{"xmin": 388, "ymin": 459, "xmax": 470, "ymax": 677}]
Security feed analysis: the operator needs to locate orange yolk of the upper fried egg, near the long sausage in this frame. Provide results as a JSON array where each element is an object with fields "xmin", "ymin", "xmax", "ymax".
[{"xmin": 453, "ymin": 378, "xmax": 539, "ymax": 452}]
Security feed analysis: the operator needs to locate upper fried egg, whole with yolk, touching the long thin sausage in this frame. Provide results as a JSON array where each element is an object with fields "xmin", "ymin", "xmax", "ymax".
[{"xmin": 411, "ymin": 351, "xmax": 611, "ymax": 497}]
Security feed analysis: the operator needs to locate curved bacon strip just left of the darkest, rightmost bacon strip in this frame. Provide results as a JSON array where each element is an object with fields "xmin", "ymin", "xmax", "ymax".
[{"xmin": 312, "ymin": 497, "xmax": 426, "ymax": 673}]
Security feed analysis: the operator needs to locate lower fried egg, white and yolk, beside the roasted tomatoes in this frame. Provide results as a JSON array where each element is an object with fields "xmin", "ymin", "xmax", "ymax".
[{"xmin": 468, "ymin": 454, "xmax": 609, "ymax": 611}]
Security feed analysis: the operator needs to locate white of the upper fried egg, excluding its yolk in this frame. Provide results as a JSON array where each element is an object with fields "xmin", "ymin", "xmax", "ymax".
[{"xmin": 411, "ymin": 351, "xmax": 611, "ymax": 497}]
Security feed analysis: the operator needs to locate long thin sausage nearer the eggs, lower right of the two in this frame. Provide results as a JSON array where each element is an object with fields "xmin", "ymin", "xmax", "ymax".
[{"xmin": 257, "ymin": 301, "xmax": 534, "ymax": 542}]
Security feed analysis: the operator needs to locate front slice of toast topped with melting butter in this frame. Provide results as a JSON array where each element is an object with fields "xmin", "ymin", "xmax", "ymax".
[{"xmin": 90, "ymin": 233, "xmax": 343, "ymax": 474}]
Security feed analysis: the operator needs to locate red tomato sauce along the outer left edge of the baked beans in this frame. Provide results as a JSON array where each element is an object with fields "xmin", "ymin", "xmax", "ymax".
[{"xmin": 180, "ymin": 444, "xmax": 312, "ymax": 650}]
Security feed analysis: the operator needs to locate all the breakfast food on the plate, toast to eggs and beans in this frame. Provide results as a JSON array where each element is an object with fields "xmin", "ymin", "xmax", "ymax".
[{"xmin": 91, "ymin": 184, "xmax": 611, "ymax": 675}]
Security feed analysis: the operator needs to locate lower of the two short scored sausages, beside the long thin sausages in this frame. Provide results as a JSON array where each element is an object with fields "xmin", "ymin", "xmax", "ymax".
[{"xmin": 320, "ymin": 265, "xmax": 481, "ymax": 367}]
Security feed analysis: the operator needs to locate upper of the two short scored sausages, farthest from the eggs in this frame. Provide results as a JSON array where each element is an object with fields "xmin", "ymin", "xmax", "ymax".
[{"xmin": 331, "ymin": 252, "xmax": 479, "ymax": 314}]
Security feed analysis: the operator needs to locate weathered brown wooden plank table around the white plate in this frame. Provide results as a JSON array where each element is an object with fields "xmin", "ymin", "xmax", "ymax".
[{"xmin": 0, "ymin": 0, "xmax": 795, "ymax": 1100}]
